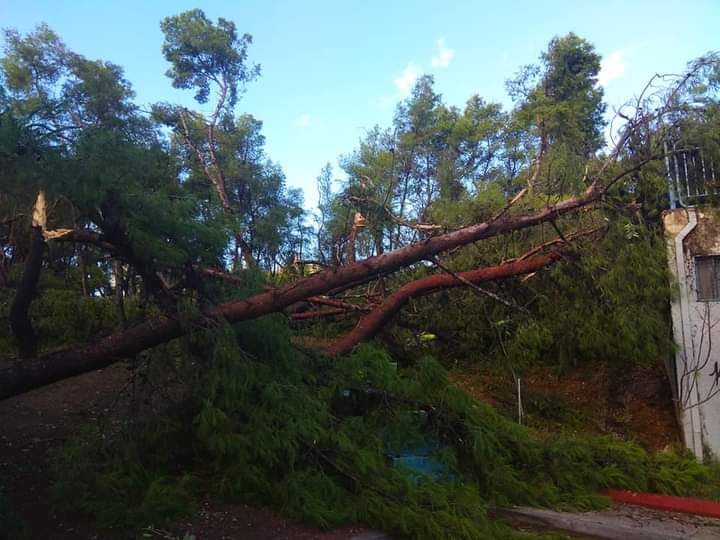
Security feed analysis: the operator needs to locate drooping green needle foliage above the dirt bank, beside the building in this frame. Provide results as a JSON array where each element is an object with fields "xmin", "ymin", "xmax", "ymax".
[{"xmin": 508, "ymin": 219, "xmax": 673, "ymax": 367}]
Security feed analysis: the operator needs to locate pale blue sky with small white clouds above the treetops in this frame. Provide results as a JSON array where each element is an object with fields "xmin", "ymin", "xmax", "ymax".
[{"xmin": 0, "ymin": 0, "xmax": 720, "ymax": 206}]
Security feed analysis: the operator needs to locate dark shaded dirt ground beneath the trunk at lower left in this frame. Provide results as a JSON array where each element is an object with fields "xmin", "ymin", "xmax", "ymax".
[{"xmin": 0, "ymin": 365, "xmax": 364, "ymax": 540}]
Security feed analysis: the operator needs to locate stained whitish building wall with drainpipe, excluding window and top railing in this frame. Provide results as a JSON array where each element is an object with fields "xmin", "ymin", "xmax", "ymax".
[{"xmin": 663, "ymin": 208, "xmax": 720, "ymax": 459}]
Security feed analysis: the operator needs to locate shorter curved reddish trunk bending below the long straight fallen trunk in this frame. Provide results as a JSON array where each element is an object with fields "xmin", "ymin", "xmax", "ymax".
[{"xmin": 325, "ymin": 250, "xmax": 562, "ymax": 356}]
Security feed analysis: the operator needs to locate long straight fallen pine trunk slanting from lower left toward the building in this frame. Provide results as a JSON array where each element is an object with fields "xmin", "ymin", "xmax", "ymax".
[{"xmin": 0, "ymin": 186, "xmax": 600, "ymax": 399}]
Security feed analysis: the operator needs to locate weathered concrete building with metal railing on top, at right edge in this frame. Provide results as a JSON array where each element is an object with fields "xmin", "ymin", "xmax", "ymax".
[{"xmin": 663, "ymin": 144, "xmax": 720, "ymax": 460}]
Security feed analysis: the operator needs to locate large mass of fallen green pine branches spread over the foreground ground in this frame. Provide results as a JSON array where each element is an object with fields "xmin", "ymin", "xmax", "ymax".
[{"xmin": 53, "ymin": 316, "xmax": 720, "ymax": 540}]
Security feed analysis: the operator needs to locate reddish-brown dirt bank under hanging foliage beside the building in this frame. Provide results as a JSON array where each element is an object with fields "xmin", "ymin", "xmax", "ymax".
[{"xmin": 451, "ymin": 363, "xmax": 681, "ymax": 450}]
